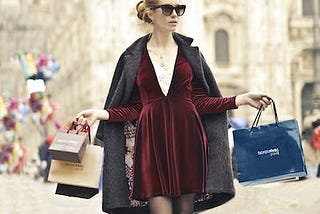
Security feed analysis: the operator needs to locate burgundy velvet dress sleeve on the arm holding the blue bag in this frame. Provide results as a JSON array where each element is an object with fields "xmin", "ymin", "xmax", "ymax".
[{"xmin": 192, "ymin": 74, "xmax": 237, "ymax": 115}]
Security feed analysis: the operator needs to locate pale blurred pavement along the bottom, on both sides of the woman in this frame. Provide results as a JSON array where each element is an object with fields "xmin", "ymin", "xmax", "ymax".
[{"xmin": 0, "ymin": 175, "xmax": 320, "ymax": 214}]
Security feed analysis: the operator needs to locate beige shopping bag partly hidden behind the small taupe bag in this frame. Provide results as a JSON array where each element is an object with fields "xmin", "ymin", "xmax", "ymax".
[{"xmin": 48, "ymin": 144, "xmax": 103, "ymax": 188}]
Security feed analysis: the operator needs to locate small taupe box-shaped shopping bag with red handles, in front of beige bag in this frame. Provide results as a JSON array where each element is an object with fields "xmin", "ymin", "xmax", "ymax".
[{"xmin": 49, "ymin": 123, "xmax": 90, "ymax": 163}]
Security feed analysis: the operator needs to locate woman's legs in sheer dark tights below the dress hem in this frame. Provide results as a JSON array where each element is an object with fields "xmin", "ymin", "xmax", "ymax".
[{"xmin": 148, "ymin": 194, "xmax": 196, "ymax": 214}]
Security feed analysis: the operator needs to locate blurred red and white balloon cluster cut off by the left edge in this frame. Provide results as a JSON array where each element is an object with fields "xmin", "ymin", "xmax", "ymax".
[{"xmin": 0, "ymin": 96, "xmax": 30, "ymax": 132}]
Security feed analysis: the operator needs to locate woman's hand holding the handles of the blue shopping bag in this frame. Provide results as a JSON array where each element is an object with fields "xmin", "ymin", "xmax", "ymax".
[{"xmin": 235, "ymin": 93, "xmax": 272, "ymax": 110}]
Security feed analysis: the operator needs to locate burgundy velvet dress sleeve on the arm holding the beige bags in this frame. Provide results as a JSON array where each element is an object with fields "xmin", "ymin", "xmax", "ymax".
[{"xmin": 106, "ymin": 84, "xmax": 142, "ymax": 122}]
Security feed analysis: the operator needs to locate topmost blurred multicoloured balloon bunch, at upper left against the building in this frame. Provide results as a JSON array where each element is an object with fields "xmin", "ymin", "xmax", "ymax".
[{"xmin": 17, "ymin": 51, "xmax": 60, "ymax": 82}]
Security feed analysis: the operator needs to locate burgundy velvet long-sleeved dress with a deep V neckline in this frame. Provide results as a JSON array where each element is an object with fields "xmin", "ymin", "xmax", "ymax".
[{"xmin": 108, "ymin": 48, "xmax": 236, "ymax": 200}]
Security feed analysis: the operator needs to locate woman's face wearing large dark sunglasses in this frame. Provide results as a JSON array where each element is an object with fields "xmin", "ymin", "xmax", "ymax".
[{"xmin": 149, "ymin": 0, "xmax": 184, "ymax": 32}]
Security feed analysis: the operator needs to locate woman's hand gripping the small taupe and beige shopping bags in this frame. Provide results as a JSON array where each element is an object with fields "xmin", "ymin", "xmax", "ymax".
[{"xmin": 75, "ymin": 109, "xmax": 109, "ymax": 126}]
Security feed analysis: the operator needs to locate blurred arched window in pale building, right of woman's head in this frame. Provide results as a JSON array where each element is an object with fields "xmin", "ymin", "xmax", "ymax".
[{"xmin": 215, "ymin": 30, "xmax": 229, "ymax": 64}]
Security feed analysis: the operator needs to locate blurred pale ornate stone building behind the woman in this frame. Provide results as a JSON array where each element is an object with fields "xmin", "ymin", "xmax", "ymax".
[{"xmin": 0, "ymin": 0, "xmax": 320, "ymax": 157}]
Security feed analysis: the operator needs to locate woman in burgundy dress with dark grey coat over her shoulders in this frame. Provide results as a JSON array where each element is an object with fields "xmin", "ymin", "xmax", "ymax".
[{"xmin": 76, "ymin": 0, "xmax": 270, "ymax": 214}]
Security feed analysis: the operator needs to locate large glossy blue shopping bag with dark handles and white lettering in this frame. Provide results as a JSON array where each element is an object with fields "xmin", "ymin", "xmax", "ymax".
[{"xmin": 233, "ymin": 101, "xmax": 307, "ymax": 185}]
